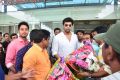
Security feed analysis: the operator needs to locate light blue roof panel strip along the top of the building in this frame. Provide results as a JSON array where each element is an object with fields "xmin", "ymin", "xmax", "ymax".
[{"xmin": 2, "ymin": 0, "xmax": 116, "ymax": 10}]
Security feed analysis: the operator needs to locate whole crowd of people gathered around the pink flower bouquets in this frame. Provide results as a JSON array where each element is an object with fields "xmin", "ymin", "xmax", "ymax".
[{"xmin": 0, "ymin": 17, "xmax": 120, "ymax": 80}]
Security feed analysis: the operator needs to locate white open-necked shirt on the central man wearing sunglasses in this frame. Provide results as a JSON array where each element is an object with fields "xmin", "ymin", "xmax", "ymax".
[{"xmin": 52, "ymin": 32, "xmax": 78, "ymax": 58}]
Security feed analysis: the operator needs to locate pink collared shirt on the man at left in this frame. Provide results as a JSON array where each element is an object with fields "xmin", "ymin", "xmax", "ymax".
[{"xmin": 5, "ymin": 37, "xmax": 28, "ymax": 68}]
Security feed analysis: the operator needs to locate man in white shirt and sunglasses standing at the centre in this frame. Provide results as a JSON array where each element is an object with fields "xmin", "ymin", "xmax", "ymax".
[{"xmin": 52, "ymin": 17, "xmax": 78, "ymax": 58}]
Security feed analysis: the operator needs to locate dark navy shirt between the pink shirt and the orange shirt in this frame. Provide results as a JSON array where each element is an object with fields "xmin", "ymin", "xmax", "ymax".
[{"xmin": 15, "ymin": 42, "xmax": 32, "ymax": 72}]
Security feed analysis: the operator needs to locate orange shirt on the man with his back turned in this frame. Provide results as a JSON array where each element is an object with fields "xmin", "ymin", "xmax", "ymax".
[{"xmin": 22, "ymin": 44, "xmax": 51, "ymax": 80}]
